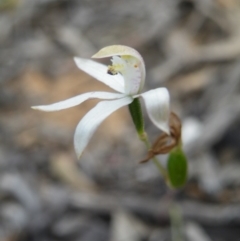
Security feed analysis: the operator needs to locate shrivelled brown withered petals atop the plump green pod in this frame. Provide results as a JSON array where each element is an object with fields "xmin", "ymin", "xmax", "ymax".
[{"xmin": 140, "ymin": 112, "xmax": 182, "ymax": 163}]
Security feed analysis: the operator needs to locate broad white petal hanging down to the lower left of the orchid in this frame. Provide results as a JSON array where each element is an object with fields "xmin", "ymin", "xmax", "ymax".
[{"xmin": 74, "ymin": 97, "xmax": 133, "ymax": 158}]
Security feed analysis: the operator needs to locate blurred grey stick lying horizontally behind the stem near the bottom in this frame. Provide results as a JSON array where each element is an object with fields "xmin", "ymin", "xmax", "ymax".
[{"xmin": 70, "ymin": 193, "xmax": 240, "ymax": 225}]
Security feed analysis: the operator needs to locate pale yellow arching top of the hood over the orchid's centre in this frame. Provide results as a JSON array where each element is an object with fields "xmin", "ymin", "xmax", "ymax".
[{"xmin": 92, "ymin": 45, "xmax": 143, "ymax": 62}]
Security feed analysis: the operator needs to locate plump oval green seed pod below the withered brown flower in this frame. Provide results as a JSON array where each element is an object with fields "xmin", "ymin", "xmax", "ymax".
[{"xmin": 167, "ymin": 147, "xmax": 188, "ymax": 188}]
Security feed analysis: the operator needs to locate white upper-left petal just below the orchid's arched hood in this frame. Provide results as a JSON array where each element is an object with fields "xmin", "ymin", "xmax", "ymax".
[{"xmin": 74, "ymin": 57, "xmax": 124, "ymax": 93}]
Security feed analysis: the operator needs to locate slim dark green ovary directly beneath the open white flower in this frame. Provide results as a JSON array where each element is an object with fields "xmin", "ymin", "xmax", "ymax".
[{"xmin": 128, "ymin": 98, "xmax": 144, "ymax": 138}]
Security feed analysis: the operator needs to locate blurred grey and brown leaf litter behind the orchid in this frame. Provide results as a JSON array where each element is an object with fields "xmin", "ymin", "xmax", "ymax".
[{"xmin": 0, "ymin": 0, "xmax": 240, "ymax": 241}]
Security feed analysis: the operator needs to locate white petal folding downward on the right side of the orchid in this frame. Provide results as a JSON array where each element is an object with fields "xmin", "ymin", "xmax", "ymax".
[{"xmin": 140, "ymin": 88, "xmax": 170, "ymax": 134}]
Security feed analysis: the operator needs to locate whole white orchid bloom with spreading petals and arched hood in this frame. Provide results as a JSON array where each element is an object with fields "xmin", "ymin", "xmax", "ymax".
[{"xmin": 32, "ymin": 45, "xmax": 169, "ymax": 157}]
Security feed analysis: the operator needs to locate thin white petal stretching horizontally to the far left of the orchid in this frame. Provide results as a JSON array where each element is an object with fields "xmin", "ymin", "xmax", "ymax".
[{"xmin": 32, "ymin": 92, "xmax": 125, "ymax": 111}]
